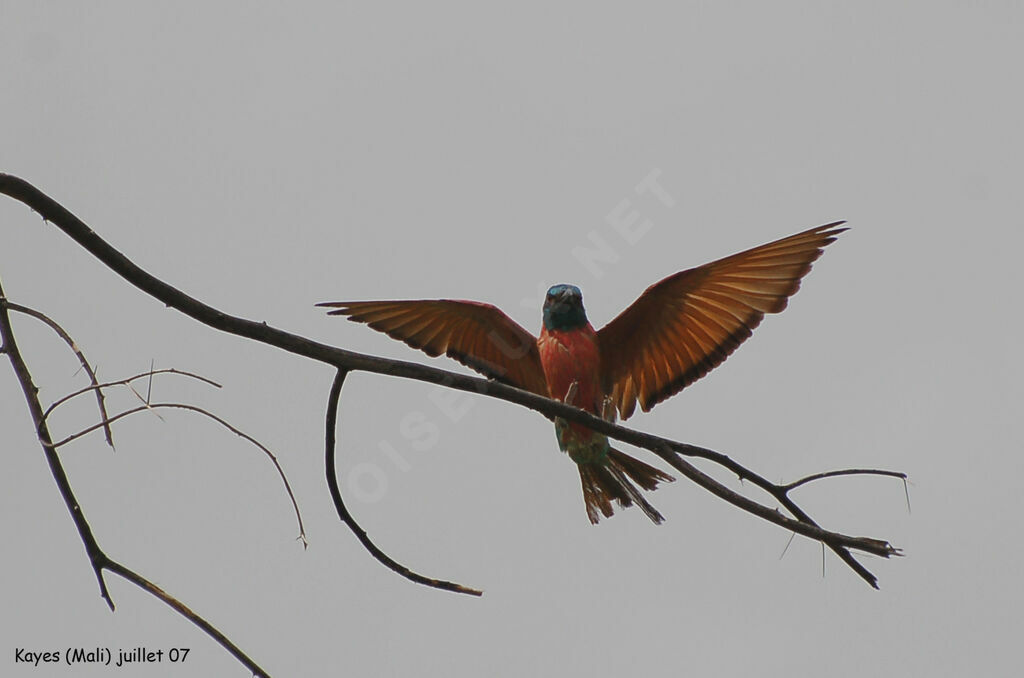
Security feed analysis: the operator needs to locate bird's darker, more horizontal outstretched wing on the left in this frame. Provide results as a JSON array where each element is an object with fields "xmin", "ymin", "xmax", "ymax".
[{"xmin": 316, "ymin": 299, "xmax": 548, "ymax": 395}]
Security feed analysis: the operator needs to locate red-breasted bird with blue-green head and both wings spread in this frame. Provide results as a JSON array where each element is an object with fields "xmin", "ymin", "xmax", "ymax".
[{"xmin": 317, "ymin": 221, "xmax": 846, "ymax": 523}]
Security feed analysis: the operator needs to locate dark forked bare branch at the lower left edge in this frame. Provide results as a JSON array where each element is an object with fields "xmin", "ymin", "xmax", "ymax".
[{"xmin": 0, "ymin": 278, "xmax": 269, "ymax": 676}]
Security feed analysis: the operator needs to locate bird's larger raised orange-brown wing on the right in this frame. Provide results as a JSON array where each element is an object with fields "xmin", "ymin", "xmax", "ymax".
[{"xmin": 597, "ymin": 221, "xmax": 846, "ymax": 419}]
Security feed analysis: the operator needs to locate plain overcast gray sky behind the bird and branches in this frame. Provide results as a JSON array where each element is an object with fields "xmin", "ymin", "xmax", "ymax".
[{"xmin": 0, "ymin": 2, "xmax": 1024, "ymax": 677}]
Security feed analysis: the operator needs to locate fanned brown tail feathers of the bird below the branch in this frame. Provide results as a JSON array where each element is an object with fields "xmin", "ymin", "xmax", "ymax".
[{"xmin": 579, "ymin": 449, "xmax": 675, "ymax": 524}]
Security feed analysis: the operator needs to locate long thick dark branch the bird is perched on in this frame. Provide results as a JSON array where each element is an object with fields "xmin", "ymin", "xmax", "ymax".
[{"xmin": 0, "ymin": 174, "xmax": 900, "ymax": 588}]
